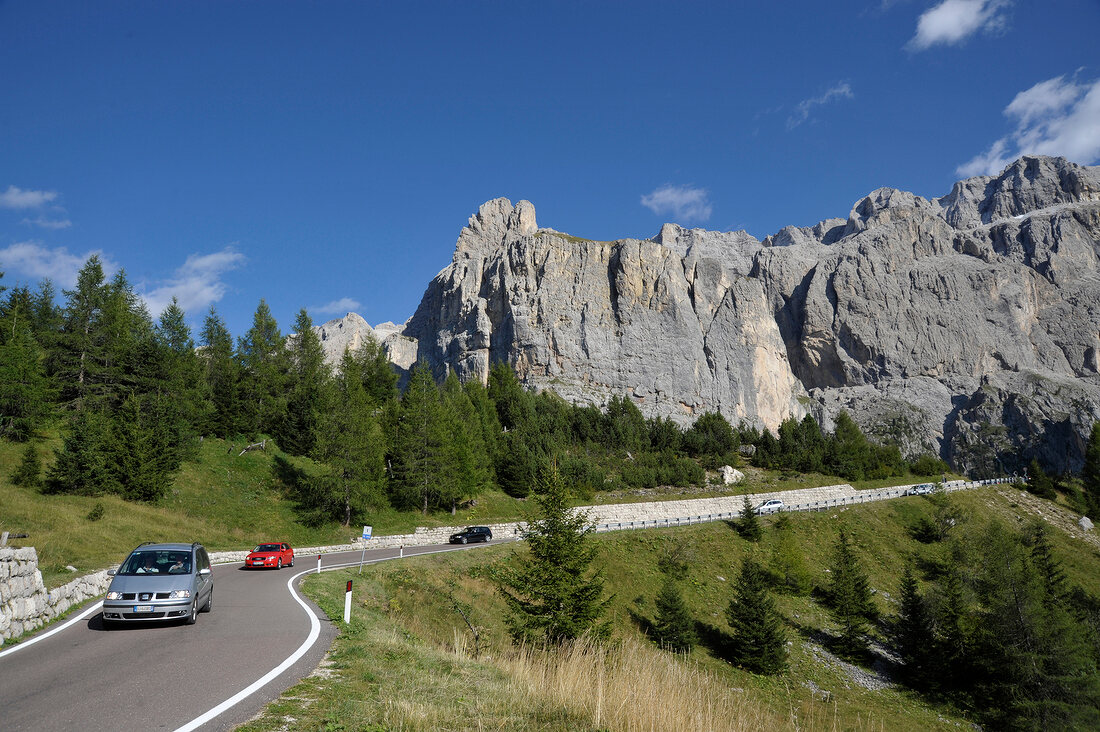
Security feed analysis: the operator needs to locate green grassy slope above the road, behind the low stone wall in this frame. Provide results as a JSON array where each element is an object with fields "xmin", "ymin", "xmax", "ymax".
[{"xmin": 0, "ymin": 436, "xmax": 946, "ymax": 587}]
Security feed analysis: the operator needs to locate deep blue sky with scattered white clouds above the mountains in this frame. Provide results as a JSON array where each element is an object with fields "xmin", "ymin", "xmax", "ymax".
[{"xmin": 0, "ymin": 0, "xmax": 1100, "ymax": 336}]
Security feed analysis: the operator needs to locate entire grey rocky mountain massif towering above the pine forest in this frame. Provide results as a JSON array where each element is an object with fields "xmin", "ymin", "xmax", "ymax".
[{"xmin": 334, "ymin": 157, "xmax": 1100, "ymax": 473}]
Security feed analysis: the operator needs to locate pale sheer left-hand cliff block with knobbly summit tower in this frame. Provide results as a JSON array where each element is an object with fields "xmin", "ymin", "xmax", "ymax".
[{"xmin": 404, "ymin": 199, "xmax": 804, "ymax": 427}]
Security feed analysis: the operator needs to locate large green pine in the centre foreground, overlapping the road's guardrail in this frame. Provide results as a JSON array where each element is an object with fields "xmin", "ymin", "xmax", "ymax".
[{"xmin": 494, "ymin": 466, "xmax": 611, "ymax": 644}]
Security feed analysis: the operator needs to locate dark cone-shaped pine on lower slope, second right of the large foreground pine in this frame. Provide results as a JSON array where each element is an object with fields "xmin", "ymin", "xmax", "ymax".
[{"xmin": 726, "ymin": 558, "xmax": 787, "ymax": 674}]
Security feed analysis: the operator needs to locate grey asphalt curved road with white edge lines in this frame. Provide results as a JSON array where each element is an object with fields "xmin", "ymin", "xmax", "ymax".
[{"xmin": 0, "ymin": 539, "xmax": 495, "ymax": 732}]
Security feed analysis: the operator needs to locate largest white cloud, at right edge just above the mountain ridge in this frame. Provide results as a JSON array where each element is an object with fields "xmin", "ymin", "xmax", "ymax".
[{"xmin": 956, "ymin": 76, "xmax": 1100, "ymax": 176}]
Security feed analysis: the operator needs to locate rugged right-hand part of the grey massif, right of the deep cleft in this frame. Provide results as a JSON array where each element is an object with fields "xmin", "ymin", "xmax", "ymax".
[{"xmin": 751, "ymin": 157, "xmax": 1100, "ymax": 474}]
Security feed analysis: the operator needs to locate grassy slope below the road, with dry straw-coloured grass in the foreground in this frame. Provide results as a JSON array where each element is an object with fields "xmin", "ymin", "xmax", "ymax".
[{"xmin": 236, "ymin": 488, "xmax": 1100, "ymax": 731}]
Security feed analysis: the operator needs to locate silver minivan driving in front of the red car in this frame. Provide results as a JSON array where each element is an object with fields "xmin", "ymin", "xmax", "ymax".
[{"xmin": 103, "ymin": 542, "xmax": 213, "ymax": 627}]
